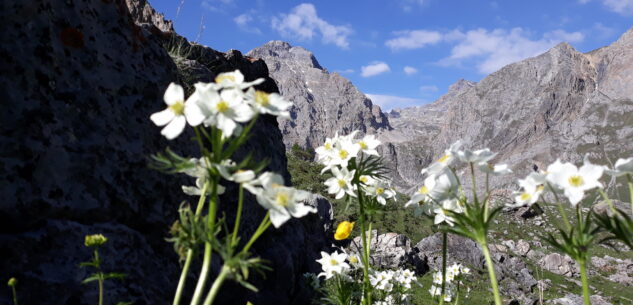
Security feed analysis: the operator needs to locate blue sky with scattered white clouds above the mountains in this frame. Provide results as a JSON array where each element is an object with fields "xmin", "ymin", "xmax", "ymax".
[{"xmin": 149, "ymin": 0, "xmax": 633, "ymax": 110}]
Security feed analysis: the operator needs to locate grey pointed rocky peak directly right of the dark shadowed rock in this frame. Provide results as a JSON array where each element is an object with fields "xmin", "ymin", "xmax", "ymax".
[{"xmin": 246, "ymin": 41, "xmax": 390, "ymax": 148}]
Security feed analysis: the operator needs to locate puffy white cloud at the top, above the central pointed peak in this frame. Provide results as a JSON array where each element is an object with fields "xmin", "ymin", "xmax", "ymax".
[{"xmin": 272, "ymin": 3, "xmax": 352, "ymax": 49}]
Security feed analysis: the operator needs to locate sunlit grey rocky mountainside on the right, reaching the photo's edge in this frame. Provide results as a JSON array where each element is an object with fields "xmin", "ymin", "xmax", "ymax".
[{"xmin": 381, "ymin": 29, "xmax": 633, "ymax": 190}]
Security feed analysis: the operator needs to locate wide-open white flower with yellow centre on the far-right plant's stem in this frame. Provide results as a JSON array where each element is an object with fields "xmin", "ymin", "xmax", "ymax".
[{"xmin": 547, "ymin": 158, "xmax": 605, "ymax": 206}]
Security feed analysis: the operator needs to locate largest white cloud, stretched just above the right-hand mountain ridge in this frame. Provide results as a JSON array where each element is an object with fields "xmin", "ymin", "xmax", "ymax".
[{"xmin": 440, "ymin": 28, "xmax": 584, "ymax": 74}]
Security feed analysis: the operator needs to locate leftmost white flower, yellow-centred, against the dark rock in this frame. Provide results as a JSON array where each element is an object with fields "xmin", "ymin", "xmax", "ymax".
[{"xmin": 149, "ymin": 83, "xmax": 200, "ymax": 140}]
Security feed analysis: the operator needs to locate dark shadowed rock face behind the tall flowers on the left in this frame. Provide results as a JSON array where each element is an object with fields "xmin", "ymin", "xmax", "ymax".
[{"xmin": 0, "ymin": 0, "xmax": 331, "ymax": 304}]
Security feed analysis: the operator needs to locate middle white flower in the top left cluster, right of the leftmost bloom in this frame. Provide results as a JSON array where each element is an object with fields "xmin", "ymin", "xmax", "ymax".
[{"xmin": 196, "ymin": 84, "xmax": 254, "ymax": 138}]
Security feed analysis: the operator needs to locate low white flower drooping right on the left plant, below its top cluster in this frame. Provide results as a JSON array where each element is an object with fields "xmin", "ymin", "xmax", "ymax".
[{"xmin": 244, "ymin": 172, "xmax": 317, "ymax": 228}]
